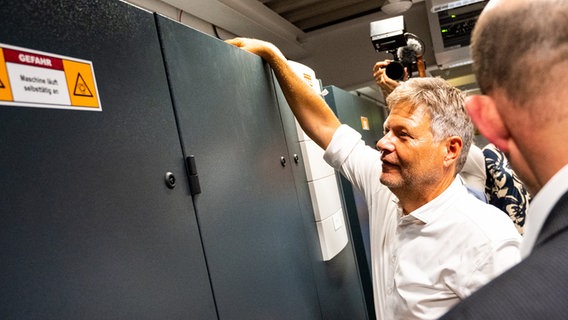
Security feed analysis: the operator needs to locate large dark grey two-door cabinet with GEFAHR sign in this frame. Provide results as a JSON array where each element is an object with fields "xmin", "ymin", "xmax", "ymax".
[{"xmin": 0, "ymin": 0, "xmax": 367, "ymax": 320}]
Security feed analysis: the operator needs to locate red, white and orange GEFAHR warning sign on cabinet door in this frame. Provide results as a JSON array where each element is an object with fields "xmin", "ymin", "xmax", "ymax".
[{"xmin": 0, "ymin": 44, "xmax": 102, "ymax": 111}]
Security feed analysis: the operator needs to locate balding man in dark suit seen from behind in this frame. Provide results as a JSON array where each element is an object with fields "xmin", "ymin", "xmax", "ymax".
[{"xmin": 442, "ymin": 0, "xmax": 568, "ymax": 320}]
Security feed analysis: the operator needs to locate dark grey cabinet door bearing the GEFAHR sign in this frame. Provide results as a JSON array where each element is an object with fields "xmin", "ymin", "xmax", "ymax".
[{"xmin": 0, "ymin": 0, "xmax": 217, "ymax": 319}]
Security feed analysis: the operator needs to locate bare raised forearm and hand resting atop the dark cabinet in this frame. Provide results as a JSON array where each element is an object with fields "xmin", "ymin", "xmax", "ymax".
[{"xmin": 226, "ymin": 38, "xmax": 341, "ymax": 149}]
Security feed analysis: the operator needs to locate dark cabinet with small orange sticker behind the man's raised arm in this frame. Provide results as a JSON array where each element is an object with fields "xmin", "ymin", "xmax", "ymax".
[{"xmin": 325, "ymin": 86, "xmax": 386, "ymax": 317}]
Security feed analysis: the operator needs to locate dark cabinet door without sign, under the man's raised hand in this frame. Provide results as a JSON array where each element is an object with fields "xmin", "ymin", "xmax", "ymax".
[{"xmin": 157, "ymin": 16, "xmax": 321, "ymax": 319}]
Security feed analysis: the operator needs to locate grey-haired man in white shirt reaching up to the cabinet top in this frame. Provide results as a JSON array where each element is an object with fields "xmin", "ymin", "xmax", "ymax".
[{"xmin": 227, "ymin": 38, "xmax": 520, "ymax": 319}]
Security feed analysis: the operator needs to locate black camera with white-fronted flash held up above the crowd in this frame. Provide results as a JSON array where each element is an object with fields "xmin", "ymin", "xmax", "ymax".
[{"xmin": 371, "ymin": 16, "xmax": 424, "ymax": 80}]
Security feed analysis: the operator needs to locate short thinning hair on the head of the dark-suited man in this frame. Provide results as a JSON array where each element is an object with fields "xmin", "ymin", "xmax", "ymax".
[{"xmin": 471, "ymin": 0, "xmax": 568, "ymax": 109}]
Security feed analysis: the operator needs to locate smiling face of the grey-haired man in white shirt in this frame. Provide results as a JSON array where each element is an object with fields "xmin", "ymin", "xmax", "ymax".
[{"xmin": 377, "ymin": 102, "xmax": 446, "ymax": 197}]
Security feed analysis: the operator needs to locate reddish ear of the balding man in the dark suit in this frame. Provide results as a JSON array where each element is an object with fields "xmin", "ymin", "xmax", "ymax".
[{"xmin": 465, "ymin": 95, "xmax": 510, "ymax": 153}]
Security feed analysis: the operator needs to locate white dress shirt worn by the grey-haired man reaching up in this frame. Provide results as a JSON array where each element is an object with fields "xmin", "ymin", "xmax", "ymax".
[{"xmin": 324, "ymin": 125, "xmax": 521, "ymax": 320}]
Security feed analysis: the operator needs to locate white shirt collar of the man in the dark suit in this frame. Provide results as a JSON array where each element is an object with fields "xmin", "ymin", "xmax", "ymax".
[{"xmin": 521, "ymin": 165, "xmax": 568, "ymax": 258}]
